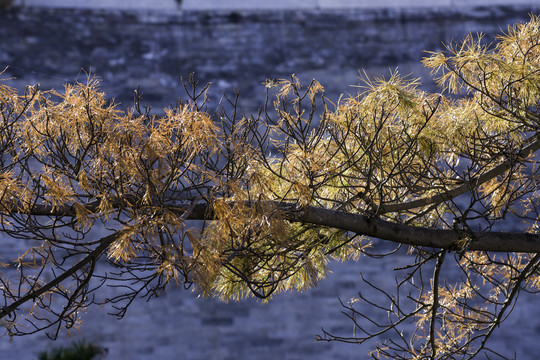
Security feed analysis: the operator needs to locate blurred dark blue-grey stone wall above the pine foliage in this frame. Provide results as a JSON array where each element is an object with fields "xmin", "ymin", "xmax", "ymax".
[{"xmin": 0, "ymin": 7, "xmax": 531, "ymax": 111}]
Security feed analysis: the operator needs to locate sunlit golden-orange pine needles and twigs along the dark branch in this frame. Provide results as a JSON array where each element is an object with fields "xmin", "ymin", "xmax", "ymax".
[{"xmin": 0, "ymin": 17, "xmax": 540, "ymax": 359}]
